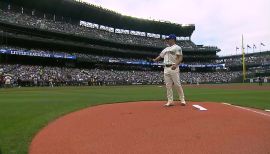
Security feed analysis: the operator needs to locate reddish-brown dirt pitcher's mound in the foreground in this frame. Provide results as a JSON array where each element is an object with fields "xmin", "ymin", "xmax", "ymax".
[{"xmin": 29, "ymin": 101, "xmax": 270, "ymax": 154}]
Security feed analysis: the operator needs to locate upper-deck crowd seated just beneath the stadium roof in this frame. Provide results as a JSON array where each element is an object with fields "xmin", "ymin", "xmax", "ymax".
[{"xmin": 0, "ymin": 9, "xmax": 197, "ymax": 49}]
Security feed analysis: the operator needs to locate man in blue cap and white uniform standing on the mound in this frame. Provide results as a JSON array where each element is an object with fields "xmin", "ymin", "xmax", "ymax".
[{"xmin": 153, "ymin": 34, "xmax": 186, "ymax": 106}]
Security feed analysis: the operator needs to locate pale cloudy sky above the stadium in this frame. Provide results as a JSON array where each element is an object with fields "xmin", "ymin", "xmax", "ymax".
[{"xmin": 83, "ymin": 0, "xmax": 270, "ymax": 56}]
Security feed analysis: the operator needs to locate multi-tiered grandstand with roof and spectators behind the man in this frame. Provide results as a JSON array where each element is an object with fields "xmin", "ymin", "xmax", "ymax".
[{"xmin": 0, "ymin": 0, "xmax": 268, "ymax": 86}]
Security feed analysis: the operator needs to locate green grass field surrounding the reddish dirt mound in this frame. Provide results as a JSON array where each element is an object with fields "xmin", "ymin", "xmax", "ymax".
[{"xmin": 0, "ymin": 85, "xmax": 270, "ymax": 154}]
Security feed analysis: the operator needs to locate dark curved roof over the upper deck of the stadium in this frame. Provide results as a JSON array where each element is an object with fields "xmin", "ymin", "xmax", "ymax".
[{"xmin": 4, "ymin": 0, "xmax": 195, "ymax": 37}]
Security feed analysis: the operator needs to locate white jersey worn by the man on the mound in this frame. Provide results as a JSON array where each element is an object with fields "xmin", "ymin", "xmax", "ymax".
[{"xmin": 160, "ymin": 44, "xmax": 182, "ymax": 65}]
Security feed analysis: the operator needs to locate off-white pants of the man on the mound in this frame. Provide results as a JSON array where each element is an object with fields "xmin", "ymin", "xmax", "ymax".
[{"xmin": 164, "ymin": 67, "xmax": 185, "ymax": 102}]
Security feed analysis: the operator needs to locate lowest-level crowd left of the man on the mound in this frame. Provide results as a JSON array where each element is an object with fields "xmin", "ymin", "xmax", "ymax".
[{"xmin": 0, "ymin": 65, "xmax": 162, "ymax": 86}]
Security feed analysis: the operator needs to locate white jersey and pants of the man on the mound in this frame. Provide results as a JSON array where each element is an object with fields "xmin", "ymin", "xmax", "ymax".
[{"xmin": 160, "ymin": 44, "xmax": 185, "ymax": 103}]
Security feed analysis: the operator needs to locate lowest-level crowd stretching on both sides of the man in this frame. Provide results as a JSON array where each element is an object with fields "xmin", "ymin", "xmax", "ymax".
[{"xmin": 0, "ymin": 64, "xmax": 244, "ymax": 86}]
